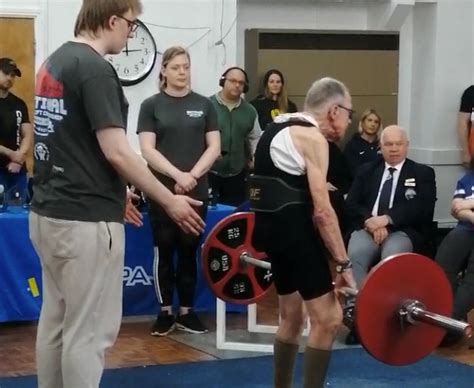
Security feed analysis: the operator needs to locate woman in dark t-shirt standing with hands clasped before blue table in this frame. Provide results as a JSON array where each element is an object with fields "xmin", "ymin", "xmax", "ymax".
[{"xmin": 137, "ymin": 46, "xmax": 220, "ymax": 336}]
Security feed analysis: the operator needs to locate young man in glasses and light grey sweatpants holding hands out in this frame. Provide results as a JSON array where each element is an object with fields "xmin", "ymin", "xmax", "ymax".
[{"xmin": 29, "ymin": 0, "xmax": 204, "ymax": 388}]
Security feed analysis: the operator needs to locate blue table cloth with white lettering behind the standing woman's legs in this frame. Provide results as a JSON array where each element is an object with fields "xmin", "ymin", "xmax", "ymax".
[{"xmin": 0, "ymin": 204, "xmax": 237, "ymax": 322}]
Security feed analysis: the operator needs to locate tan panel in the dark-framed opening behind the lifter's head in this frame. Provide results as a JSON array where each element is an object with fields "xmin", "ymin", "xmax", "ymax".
[{"xmin": 246, "ymin": 41, "xmax": 398, "ymax": 146}]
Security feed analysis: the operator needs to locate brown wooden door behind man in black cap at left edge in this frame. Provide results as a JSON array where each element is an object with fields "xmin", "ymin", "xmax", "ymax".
[{"xmin": 0, "ymin": 17, "xmax": 35, "ymax": 173}]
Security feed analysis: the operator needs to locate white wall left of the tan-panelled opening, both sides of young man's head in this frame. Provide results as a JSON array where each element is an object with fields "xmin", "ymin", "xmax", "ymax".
[{"xmin": 0, "ymin": 0, "xmax": 236, "ymax": 152}]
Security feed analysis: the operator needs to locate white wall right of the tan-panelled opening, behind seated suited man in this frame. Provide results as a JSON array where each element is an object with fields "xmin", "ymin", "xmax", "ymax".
[{"xmin": 399, "ymin": 0, "xmax": 474, "ymax": 223}]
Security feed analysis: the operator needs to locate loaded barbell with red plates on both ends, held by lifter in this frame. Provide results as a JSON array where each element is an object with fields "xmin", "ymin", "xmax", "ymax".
[{"xmin": 201, "ymin": 212, "xmax": 472, "ymax": 365}]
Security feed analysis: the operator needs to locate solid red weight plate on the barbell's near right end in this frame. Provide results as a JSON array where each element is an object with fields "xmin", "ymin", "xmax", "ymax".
[{"xmin": 355, "ymin": 253, "xmax": 453, "ymax": 365}]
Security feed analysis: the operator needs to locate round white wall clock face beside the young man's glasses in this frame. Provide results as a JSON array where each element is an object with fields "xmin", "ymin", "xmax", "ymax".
[{"xmin": 106, "ymin": 20, "xmax": 156, "ymax": 86}]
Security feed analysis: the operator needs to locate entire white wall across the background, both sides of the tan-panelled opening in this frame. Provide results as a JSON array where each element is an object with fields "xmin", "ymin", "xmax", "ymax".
[{"xmin": 0, "ymin": 0, "xmax": 474, "ymax": 222}]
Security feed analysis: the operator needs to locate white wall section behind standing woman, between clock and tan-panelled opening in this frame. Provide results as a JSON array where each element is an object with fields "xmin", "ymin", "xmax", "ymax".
[{"xmin": 125, "ymin": 0, "xmax": 236, "ymax": 150}]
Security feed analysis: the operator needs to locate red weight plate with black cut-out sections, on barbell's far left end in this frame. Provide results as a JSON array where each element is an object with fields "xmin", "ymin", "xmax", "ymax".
[{"xmin": 201, "ymin": 212, "xmax": 272, "ymax": 304}]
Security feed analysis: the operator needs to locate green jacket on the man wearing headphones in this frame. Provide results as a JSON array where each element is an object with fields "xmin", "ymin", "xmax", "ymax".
[{"xmin": 210, "ymin": 94, "xmax": 262, "ymax": 177}]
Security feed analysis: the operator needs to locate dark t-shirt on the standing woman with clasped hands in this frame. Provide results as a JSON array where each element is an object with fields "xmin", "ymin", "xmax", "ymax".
[{"xmin": 137, "ymin": 92, "xmax": 218, "ymax": 200}]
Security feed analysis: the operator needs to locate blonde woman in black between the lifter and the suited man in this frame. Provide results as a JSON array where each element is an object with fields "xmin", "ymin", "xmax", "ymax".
[{"xmin": 344, "ymin": 108, "xmax": 382, "ymax": 176}]
